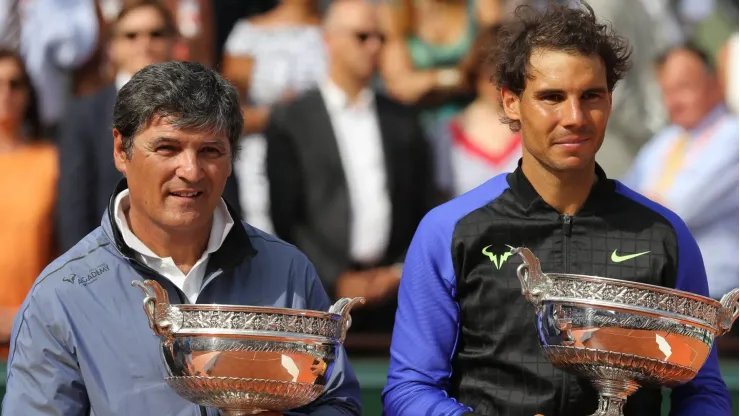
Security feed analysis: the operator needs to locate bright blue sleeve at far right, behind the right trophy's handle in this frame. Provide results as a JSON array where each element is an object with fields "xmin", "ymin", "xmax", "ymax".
[{"xmin": 671, "ymin": 220, "xmax": 731, "ymax": 416}]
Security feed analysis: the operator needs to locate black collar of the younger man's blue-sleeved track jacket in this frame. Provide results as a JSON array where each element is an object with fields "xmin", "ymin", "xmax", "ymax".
[{"xmin": 506, "ymin": 159, "xmax": 616, "ymax": 215}]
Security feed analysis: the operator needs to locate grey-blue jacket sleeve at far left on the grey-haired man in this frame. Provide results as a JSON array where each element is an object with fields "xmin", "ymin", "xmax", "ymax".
[{"xmin": 2, "ymin": 292, "xmax": 89, "ymax": 416}]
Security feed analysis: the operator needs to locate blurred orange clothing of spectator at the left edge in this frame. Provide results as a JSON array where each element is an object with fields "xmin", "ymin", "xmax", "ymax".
[{"xmin": 0, "ymin": 143, "xmax": 59, "ymax": 359}]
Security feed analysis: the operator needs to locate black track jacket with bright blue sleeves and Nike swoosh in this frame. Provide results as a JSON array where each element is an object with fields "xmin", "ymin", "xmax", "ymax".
[{"xmin": 383, "ymin": 162, "xmax": 730, "ymax": 416}]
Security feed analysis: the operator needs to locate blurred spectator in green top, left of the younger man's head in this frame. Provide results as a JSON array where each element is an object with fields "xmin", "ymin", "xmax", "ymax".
[{"xmin": 381, "ymin": 0, "xmax": 503, "ymax": 133}]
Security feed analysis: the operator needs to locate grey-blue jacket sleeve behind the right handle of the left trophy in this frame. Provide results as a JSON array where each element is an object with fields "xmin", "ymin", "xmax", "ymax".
[{"xmin": 285, "ymin": 256, "xmax": 362, "ymax": 416}]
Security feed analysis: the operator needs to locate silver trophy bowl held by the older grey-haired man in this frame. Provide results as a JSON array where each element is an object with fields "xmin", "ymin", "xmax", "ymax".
[{"xmin": 131, "ymin": 280, "xmax": 365, "ymax": 416}]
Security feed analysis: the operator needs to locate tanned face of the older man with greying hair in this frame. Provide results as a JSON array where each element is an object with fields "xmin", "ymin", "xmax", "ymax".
[{"xmin": 113, "ymin": 119, "xmax": 231, "ymax": 231}]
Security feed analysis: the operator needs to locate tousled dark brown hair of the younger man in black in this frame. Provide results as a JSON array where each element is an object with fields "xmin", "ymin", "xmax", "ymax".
[{"xmin": 490, "ymin": 0, "xmax": 632, "ymax": 131}]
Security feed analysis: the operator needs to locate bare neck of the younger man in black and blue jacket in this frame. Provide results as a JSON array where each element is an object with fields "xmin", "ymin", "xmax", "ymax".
[{"xmin": 522, "ymin": 153, "xmax": 596, "ymax": 215}]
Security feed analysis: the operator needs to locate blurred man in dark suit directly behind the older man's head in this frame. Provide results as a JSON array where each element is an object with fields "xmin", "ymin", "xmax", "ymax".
[{"xmin": 56, "ymin": 0, "xmax": 239, "ymax": 251}]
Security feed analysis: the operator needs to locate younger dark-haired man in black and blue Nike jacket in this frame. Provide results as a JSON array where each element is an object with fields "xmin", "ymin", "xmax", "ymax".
[{"xmin": 383, "ymin": 1, "xmax": 730, "ymax": 416}]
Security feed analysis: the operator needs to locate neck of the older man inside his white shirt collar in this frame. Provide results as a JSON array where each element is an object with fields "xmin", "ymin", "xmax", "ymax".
[{"xmin": 124, "ymin": 207, "xmax": 213, "ymax": 274}]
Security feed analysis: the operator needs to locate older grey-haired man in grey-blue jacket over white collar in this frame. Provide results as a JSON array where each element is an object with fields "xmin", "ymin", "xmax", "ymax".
[{"xmin": 2, "ymin": 62, "xmax": 361, "ymax": 416}]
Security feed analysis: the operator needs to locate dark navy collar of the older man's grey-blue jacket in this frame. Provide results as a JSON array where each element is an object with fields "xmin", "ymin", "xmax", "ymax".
[{"xmin": 101, "ymin": 178, "xmax": 257, "ymax": 275}]
